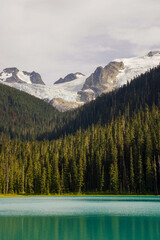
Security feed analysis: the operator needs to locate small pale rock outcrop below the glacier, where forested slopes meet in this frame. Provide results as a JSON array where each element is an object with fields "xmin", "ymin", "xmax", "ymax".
[{"xmin": 49, "ymin": 98, "xmax": 82, "ymax": 112}]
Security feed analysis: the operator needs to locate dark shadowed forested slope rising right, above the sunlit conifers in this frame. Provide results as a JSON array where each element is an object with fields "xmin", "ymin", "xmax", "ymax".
[{"xmin": 53, "ymin": 66, "xmax": 160, "ymax": 139}]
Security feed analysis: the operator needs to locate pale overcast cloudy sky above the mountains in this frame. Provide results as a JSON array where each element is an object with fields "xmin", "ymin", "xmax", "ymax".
[{"xmin": 0, "ymin": 0, "xmax": 160, "ymax": 83}]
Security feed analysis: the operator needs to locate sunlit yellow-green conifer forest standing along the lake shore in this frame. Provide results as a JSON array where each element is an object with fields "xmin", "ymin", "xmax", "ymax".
[{"xmin": 0, "ymin": 105, "xmax": 160, "ymax": 194}]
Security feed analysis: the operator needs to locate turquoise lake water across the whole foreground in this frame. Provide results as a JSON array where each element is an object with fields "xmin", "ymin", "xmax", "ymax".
[{"xmin": 0, "ymin": 197, "xmax": 160, "ymax": 240}]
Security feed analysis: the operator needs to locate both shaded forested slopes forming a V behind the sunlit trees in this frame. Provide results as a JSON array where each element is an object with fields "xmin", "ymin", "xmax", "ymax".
[{"xmin": 0, "ymin": 66, "xmax": 160, "ymax": 140}]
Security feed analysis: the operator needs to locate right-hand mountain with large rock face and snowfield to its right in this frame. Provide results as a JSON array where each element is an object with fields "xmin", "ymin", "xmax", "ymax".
[{"xmin": 79, "ymin": 51, "xmax": 160, "ymax": 101}]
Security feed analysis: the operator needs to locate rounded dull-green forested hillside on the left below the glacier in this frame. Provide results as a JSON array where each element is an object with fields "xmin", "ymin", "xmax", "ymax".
[{"xmin": 0, "ymin": 84, "xmax": 63, "ymax": 140}]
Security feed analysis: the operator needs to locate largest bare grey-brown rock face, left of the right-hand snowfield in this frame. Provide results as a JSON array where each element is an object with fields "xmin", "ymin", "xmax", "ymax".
[{"xmin": 79, "ymin": 62, "xmax": 124, "ymax": 101}]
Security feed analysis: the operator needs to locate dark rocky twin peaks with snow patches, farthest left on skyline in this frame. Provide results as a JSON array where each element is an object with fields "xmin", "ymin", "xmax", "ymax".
[{"xmin": 0, "ymin": 67, "xmax": 45, "ymax": 85}]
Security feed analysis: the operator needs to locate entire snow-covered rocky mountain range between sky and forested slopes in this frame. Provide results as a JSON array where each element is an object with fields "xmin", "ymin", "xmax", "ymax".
[{"xmin": 0, "ymin": 51, "xmax": 160, "ymax": 110}]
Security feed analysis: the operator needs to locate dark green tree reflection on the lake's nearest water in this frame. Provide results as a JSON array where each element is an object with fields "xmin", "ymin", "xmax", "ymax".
[{"xmin": 0, "ymin": 215, "xmax": 160, "ymax": 240}]
